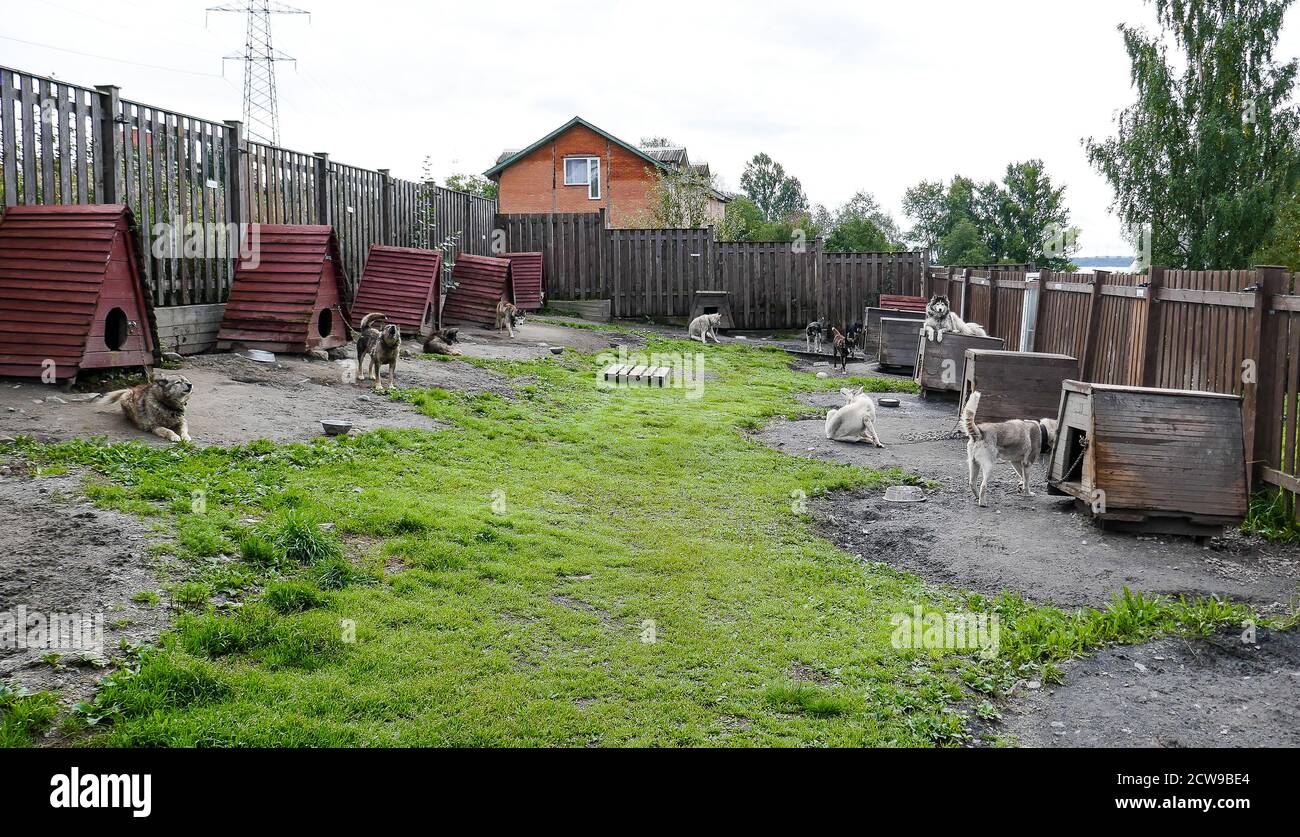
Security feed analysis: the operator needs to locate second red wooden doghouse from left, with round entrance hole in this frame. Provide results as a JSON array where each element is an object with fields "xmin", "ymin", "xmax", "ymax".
[{"xmin": 217, "ymin": 224, "xmax": 348, "ymax": 352}]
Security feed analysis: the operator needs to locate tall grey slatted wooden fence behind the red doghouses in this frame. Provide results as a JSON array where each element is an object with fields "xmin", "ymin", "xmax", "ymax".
[{"xmin": 0, "ymin": 66, "xmax": 497, "ymax": 305}]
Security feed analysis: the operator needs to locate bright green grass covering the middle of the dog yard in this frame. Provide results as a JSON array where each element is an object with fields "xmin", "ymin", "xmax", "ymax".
[{"xmin": 5, "ymin": 335, "xmax": 1268, "ymax": 746}]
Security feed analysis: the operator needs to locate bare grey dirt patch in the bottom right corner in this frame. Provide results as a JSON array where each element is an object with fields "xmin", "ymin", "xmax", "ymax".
[{"xmin": 992, "ymin": 628, "xmax": 1300, "ymax": 747}]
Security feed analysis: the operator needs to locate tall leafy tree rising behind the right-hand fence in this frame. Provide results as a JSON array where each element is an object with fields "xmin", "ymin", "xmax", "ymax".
[{"xmin": 1084, "ymin": 0, "xmax": 1300, "ymax": 269}]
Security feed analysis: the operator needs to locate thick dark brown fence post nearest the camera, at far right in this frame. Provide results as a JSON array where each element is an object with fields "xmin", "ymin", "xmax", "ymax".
[{"xmin": 1242, "ymin": 265, "xmax": 1291, "ymax": 490}]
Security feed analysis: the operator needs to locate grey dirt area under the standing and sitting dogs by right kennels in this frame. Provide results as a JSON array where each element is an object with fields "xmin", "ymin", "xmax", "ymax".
[{"xmin": 758, "ymin": 393, "xmax": 1300, "ymax": 612}]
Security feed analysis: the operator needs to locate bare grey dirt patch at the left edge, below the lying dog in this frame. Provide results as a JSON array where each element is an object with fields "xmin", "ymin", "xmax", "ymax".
[{"xmin": 0, "ymin": 474, "xmax": 168, "ymax": 706}]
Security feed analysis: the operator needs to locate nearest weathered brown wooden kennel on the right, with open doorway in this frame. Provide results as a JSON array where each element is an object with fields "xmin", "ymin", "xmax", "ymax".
[{"xmin": 1045, "ymin": 381, "xmax": 1247, "ymax": 535}]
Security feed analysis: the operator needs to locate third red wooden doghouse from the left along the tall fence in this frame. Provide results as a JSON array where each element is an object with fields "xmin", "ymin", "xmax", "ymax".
[{"xmin": 352, "ymin": 244, "xmax": 442, "ymax": 335}]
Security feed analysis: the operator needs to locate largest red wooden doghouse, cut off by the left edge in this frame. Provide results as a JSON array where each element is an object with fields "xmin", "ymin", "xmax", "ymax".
[{"xmin": 0, "ymin": 204, "xmax": 157, "ymax": 380}]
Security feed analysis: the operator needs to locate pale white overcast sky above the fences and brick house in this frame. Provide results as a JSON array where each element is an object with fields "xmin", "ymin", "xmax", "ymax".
[{"xmin": 0, "ymin": 0, "xmax": 1300, "ymax": 255}]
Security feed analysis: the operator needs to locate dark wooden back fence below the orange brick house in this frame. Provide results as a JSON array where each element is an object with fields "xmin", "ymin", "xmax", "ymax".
[{"xmin": 497, "ymin": 212, "xmax": 927, "ymax": 329}]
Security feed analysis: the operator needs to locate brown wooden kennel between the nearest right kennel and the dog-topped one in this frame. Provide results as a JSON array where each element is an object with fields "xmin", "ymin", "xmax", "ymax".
[{"xmin": 957, "ymin": 348, "xmax": 1079, "ymax": 421}]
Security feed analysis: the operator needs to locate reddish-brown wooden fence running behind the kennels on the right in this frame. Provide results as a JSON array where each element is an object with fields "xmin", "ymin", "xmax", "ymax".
[{"xmin": 926, "ymin": 266, "xmax": 1300, "ymax": 506}]
